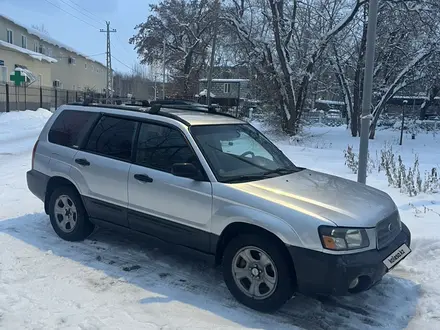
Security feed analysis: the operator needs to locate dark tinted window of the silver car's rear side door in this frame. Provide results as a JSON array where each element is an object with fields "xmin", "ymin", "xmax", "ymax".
[{"xmin": 85, "ymin": 116, "xmax": 136, "ymax": 160}]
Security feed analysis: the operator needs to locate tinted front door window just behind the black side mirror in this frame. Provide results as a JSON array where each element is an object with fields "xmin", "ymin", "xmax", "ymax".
[{"xmin": 136, "ymin": 124, "xmax": 199, "ymax": 172}]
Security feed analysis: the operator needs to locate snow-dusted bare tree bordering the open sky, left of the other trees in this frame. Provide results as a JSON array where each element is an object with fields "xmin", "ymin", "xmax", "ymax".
[{"xmin": 130, "ymin": 0, "xmax": 220, "ymax": 95}]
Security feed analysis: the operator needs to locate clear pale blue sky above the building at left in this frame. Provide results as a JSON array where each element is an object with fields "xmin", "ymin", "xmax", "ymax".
[{"xmin": 0, "ymin": 0, "xmax": 158, "ymax": 73}]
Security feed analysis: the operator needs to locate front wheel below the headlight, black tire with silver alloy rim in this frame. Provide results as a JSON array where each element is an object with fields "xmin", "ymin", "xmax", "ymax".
[{"xmin": 222, "ymin": 234, "xmax": 294, "ymax": 313}]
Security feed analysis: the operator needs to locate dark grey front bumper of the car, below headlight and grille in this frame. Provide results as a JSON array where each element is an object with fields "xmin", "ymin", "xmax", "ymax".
[{"xmin": 287, "ymin": 223, "xmax": 411, "ymax": 296}]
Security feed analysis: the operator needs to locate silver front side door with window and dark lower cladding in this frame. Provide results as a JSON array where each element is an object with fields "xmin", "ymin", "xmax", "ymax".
[{"xmin": 128, "ymin": 123, "xmax": 212, "ymax": 252}]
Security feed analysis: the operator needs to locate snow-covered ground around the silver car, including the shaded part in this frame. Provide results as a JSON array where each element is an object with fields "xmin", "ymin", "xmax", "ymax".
[{"xmin": 0, "ymin": 109, "xmax": 440, "ymax": 330}]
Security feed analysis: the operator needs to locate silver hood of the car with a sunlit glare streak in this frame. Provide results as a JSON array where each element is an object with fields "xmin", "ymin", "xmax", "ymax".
[{"xmin": 237, "ymin": 170, "xmax": 396, "ymax": 227}]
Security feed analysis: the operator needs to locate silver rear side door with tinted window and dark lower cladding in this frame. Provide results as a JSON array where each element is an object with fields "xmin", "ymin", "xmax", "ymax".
[{"xmin": 71, "ymin": 114, "xmax": 138, "ymax": 227}]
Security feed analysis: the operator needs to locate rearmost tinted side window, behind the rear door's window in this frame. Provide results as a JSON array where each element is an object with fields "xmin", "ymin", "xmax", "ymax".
[{"xmin": 49, "ymin": 110, "xmax": 99, "ymax": 147}]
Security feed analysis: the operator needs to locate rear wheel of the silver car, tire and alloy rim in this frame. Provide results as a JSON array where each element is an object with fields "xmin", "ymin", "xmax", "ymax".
[{"xmin": 49, "ymin": 186, "xmax": 95, "ymax": 242}]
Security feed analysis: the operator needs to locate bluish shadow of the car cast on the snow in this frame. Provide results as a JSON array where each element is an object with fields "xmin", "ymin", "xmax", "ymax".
[{"xmin": 0, "ymin": 213, "xmax": 419, "ymax": 330}]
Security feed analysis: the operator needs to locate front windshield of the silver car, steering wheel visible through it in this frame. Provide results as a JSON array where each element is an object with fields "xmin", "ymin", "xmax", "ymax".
[{"xmin": 190, "ymin": 124, "xmax": 299, "ymax": 183}]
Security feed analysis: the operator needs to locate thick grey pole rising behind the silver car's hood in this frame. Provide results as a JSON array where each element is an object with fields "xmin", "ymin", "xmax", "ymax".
[{"xmin": 358, "ymin": 0, "xmax": 378, "ymax": 184}]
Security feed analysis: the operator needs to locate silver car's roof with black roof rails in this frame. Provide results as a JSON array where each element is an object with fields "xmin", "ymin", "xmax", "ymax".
[{"xmin": 60, "ymin": 104, "xmax": 244, "ymax": 126}]
